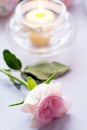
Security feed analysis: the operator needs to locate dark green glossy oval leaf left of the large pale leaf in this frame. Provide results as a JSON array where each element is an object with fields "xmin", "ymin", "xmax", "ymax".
[{"xmin": 3, "ymin": 50, "xmax": 22, "ymax": 70}]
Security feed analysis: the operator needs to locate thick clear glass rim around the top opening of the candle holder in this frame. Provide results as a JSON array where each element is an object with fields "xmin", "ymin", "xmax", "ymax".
[{"xmin": 15, "ymin": 0, "xmax": 67, "ymax": 27}]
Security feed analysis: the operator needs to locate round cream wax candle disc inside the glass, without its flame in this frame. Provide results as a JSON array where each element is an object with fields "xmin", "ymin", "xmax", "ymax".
[{"xmin": 25, "ymin": 9, "xmax": 55, "ymax": 25}]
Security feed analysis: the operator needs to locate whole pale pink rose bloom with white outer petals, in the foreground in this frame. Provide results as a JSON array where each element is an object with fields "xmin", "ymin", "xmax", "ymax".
[{"xmin": 22, "ymin": 83, "xmax": 71, "ymax": 128}]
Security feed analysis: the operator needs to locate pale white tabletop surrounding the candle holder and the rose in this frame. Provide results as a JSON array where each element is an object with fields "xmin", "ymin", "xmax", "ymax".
[{"xmin": 0, "ymin": 0, "xmax": 87, "ymax": 130}]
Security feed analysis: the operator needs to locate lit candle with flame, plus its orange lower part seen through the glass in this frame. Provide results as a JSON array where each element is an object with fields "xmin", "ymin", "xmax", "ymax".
[{"xmin": 25, "ymin": 0, "xmax": 55, "ymax": 46}]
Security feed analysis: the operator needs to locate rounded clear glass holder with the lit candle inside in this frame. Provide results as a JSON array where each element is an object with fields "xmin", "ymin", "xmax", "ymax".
[{"xmin": 7, "ymin": 0, "xmax": 75, "ymax": 56}]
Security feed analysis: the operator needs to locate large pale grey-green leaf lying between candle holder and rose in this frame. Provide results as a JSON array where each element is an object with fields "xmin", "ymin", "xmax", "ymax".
[{"xmin": 24, "ymin": 62, "xmax": 70, "ymax": 81}]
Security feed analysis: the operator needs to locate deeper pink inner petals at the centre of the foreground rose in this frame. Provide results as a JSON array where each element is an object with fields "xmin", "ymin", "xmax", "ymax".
[{"xmin": 37, "ymin": 95, "xmax": 65, "ymax": 124}]
